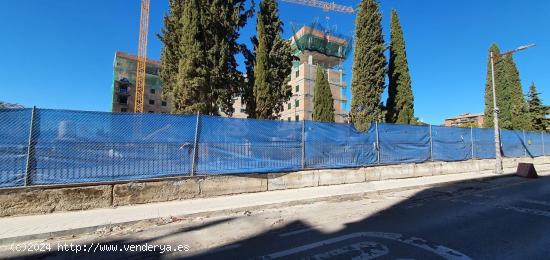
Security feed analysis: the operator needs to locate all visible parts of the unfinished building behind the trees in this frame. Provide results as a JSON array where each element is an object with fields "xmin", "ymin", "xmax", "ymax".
[{"xmin": 112, "ymin": 24, "xmax": 351, "ymax": 123}]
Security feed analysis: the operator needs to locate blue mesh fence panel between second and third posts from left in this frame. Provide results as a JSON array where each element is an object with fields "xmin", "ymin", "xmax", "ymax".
[{"xmin": 196, "ymin": 115, "xmax": 302, "ymax": 174}]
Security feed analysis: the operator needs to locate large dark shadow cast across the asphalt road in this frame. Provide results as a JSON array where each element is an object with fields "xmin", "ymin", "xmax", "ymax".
[{"xmin": 8, "ymin": 173, "xmax": 550, "ymax": 259}]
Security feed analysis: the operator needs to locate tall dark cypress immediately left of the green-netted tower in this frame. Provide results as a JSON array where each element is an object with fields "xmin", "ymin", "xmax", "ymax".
[{"xmin": 253, "ymin": 0, "xmax": 294, "ymax": 119}]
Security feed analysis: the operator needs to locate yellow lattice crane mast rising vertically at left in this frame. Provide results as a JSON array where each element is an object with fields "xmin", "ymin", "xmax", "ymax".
[{"xmin": 134, "ymin": 0, "xmax": 151, "ymax": 113}]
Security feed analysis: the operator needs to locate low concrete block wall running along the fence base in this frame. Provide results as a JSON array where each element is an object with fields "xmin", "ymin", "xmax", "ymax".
[{"xmin": 0, "ymin": 156, "xmax": 550, "ymax": 217}]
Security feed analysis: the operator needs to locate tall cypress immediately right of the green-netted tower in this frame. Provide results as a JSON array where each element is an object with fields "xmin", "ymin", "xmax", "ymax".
[{"xmin": 350, "ymin": 0, "xmax": 386, "ymax": 131}]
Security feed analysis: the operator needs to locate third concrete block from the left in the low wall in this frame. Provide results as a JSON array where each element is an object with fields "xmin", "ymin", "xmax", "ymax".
[{"xmin": 199, "ymin": 174, "xmax": 267, "ymax": 197}]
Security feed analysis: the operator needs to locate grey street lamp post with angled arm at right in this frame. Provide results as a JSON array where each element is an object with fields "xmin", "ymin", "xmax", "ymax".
[{"xmin": 491, "ymin": 44, "xmax": 535, "ymax": 174}]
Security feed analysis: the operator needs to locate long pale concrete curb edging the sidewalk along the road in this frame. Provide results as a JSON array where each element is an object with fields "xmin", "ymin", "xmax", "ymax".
[{"xmin": 0, "ymin": 173, "xmax": 522, "ymax": 244}]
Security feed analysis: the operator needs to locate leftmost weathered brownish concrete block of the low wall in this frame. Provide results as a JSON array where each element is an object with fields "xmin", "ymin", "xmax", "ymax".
[{"xmin": 0, "ymin": 185, "xmax": 112, "ymax": 217}]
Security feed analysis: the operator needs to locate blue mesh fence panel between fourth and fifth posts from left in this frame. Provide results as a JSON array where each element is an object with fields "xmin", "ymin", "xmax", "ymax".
[{"xmin": 380, "ymin": 124, "xmax": 430, "ymax": 163}]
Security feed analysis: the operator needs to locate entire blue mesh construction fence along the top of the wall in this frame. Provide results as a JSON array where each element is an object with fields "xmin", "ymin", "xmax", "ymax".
[{"xmin": 0, "ymin": 109, "xmax": 550, "ymax": 187}]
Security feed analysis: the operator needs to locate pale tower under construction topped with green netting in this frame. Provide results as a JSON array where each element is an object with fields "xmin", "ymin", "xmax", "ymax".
[{"xmin": 281, "ymin": 23, "xmax": 351, "ymax": 123}]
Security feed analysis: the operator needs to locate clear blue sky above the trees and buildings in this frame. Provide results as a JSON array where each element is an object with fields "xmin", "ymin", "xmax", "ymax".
[{"xmin": 0, "ymin": 0, "xmax": 550, "ymax": 124}]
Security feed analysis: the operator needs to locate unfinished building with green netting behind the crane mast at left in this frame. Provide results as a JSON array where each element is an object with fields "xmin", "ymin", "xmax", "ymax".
[{"xmin": 112, "ymin": 51, "xmax": 171, "ymax": 113}]
